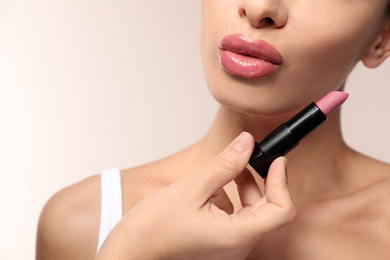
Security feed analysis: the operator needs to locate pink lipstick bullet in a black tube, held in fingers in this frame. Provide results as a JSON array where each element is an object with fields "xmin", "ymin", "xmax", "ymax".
[{"xmin": 249, "ymin": 91, "xmax": 349, "ymax": 179}]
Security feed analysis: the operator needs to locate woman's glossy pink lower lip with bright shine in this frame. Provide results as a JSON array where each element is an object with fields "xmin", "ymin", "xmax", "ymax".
[{"xmin": 219, "ymin": 49, "xmax": 279, "ymax": 79}]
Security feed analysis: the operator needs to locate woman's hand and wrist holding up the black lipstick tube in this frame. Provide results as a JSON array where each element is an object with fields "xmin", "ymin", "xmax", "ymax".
[{"xmin": 96, "ymin": 132, "xmax": 296, "ymax": 260}]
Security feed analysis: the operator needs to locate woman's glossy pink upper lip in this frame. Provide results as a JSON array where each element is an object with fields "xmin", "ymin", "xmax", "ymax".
[{"xmin": 219, "ymin": 34, "xmax": 282, "ymax": 64}]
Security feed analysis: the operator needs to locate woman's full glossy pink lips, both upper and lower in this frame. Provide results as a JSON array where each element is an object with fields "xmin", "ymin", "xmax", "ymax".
[{"xmin": 219, "ymin": 34, "xmax": 282, "ymax": 78}]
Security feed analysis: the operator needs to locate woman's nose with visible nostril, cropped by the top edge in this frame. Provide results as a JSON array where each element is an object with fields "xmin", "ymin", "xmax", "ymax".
[{"xmin": 238, "ymin": 0, "xmax": 288, "ymax": 28}]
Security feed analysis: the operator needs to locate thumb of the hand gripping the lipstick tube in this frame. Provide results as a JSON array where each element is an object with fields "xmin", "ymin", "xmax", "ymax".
[{"xmin": 189, "ymin": 132, "xmax": 254, "ymax": 200}]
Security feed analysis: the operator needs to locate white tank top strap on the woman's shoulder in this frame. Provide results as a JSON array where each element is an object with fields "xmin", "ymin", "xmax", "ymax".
[{"xmin": 97, "ymin": 168, "xmax": 123, "ymax": 251}]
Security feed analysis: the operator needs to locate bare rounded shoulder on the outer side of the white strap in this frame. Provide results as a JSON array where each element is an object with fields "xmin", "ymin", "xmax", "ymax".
[{"xmin": 37, "ymin": 175, "xmax": 101, "ymax": 259}]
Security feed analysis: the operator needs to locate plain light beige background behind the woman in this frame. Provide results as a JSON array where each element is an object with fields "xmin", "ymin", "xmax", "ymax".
[{"xmin": 0, "ymin": 0, "xmax": 390, "ymax": 259}]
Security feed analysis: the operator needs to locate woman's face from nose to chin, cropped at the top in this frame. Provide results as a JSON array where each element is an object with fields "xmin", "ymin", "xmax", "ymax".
[{"xmin": 201, "ymin": 0, "xmax": 386, "ymax": 116}]
